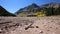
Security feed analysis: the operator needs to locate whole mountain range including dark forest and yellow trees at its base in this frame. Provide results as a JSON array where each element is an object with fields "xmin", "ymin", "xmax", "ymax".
[{"xmin": 15, "ymin": 2, "xmax": 60, "ymax": 16}]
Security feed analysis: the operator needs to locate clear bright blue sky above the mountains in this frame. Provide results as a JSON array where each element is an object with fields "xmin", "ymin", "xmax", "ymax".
[{"xmin": 0, "ymin": 0, "xmax": 60, "ymax": 13}]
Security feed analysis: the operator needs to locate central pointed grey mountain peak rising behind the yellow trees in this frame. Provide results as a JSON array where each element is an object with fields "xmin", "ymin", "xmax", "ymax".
[{"xmin": 15, "ymin": 3, "xmax": 40, "ymax": 14}]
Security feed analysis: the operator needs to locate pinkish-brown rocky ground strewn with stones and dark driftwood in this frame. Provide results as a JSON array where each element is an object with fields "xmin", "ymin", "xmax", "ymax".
[{"xmin": 0, "ymin": 17, "xmax": 60, "ymax": 34}]
